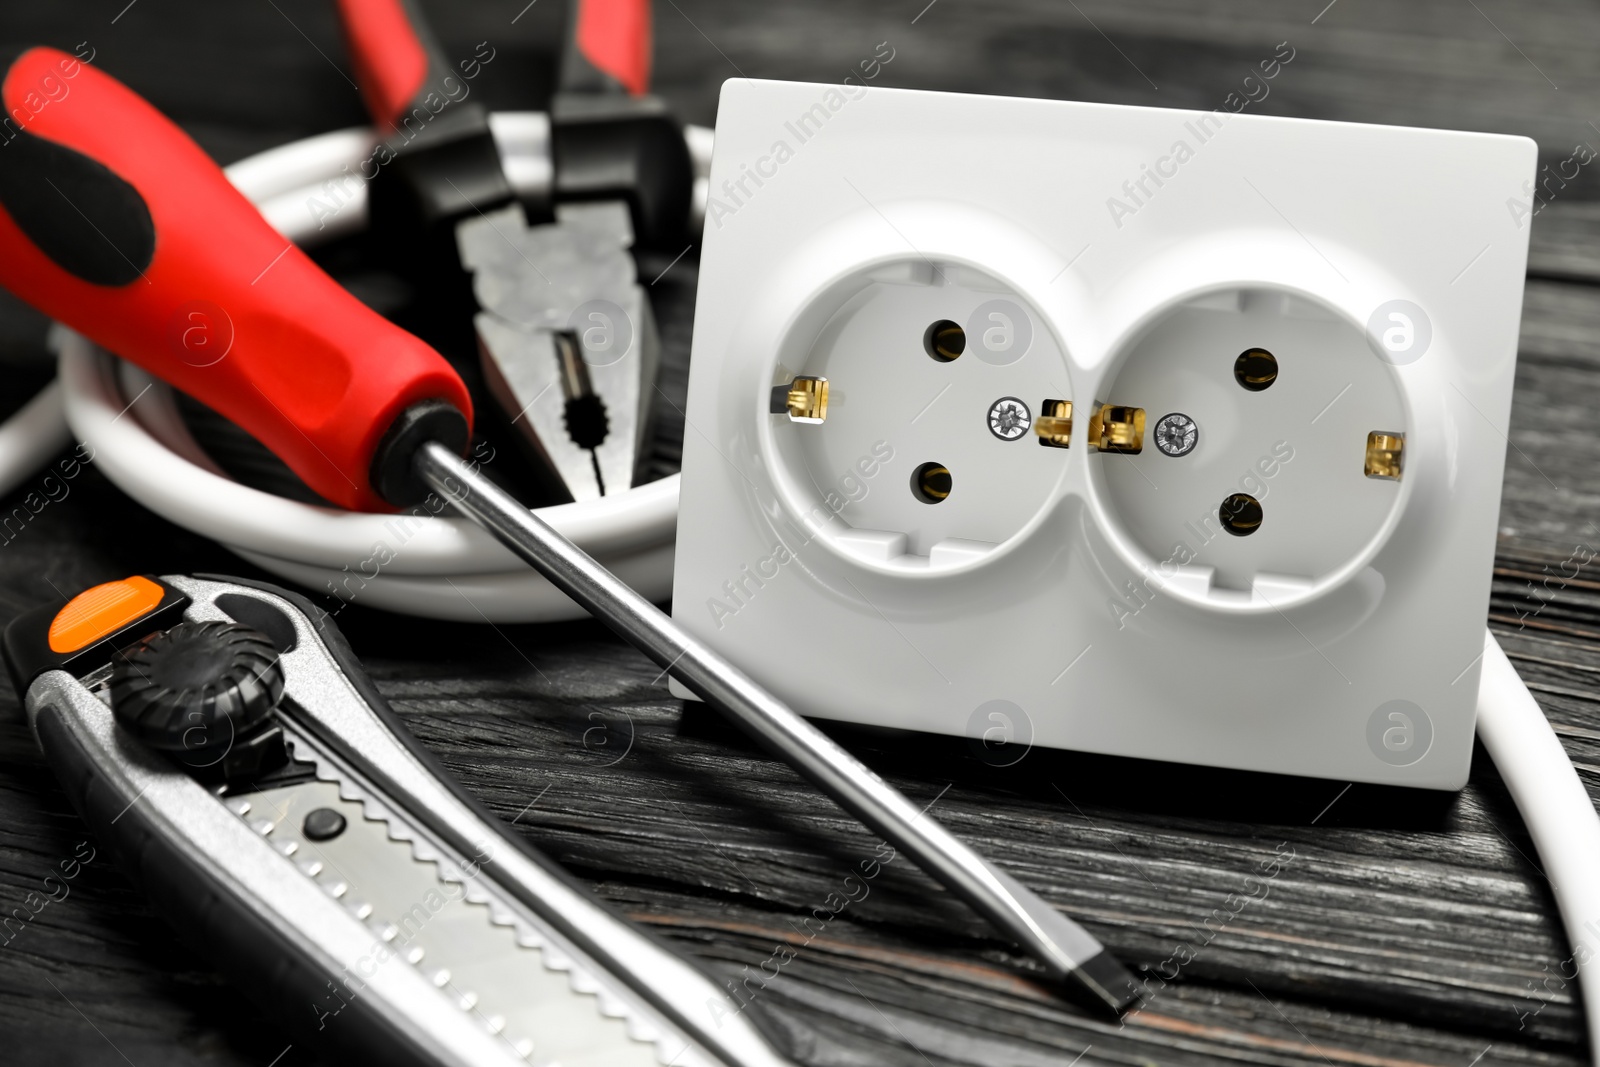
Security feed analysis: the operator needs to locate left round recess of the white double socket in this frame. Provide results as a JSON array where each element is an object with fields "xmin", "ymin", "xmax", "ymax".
[{"xmin": 771, "ymin": 258, "xmax": 1072, "ymax": 574}]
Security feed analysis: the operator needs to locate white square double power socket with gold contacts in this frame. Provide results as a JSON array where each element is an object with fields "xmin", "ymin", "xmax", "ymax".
[{"xmin": 674, "ymin": 80, "xmax": 1536, "ymax": 789}]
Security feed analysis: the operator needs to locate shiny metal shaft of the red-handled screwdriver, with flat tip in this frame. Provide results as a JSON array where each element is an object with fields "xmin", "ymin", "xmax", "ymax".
[{"xmin": 414, "ymin": 442, "xmax": 1139, "ymax": 1014}]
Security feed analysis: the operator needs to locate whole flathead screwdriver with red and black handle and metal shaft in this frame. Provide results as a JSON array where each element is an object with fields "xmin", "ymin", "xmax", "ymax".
[{"xmin": 0, "ymin": 48, "xmax": 1139, "ymax": 1014}]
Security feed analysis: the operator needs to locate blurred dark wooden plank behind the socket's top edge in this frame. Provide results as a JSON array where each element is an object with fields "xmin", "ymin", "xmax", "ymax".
[{"xmin": 656, "ymin": 0, "xmax": 1600, "ymax": 154}]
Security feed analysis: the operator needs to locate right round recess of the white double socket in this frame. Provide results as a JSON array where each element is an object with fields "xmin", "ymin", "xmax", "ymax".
[{"xmin": 1083, "ymin": 286, "xmax": 1410, "ymax": 613}]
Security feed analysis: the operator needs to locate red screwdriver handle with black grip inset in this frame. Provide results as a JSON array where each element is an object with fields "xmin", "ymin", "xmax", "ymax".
[{"xmin": 0, "ymin": 48, "xmax": 472, "ymax": 510}]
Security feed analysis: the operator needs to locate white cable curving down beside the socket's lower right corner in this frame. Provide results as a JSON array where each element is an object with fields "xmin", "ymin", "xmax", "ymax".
[{"xmin": 1478, "ymin": 633, "xmax": 1600, "ymax": 1064}]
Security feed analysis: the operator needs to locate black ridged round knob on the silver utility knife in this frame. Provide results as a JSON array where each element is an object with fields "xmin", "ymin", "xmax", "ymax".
[{"xmin": 110, "ymin": 621, "xmax": 283, "ymax": 752}]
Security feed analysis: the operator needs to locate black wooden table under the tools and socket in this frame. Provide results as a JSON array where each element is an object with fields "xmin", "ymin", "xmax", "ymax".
[{"xmin": 0, "ymin": 0, "xmax": 1600, "ymax": 1067}]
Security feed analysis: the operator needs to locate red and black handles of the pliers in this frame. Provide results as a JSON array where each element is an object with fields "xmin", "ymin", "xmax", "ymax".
[{"xmin": 338, "ymin": 0, "xmax": 694, "ymax": 244}]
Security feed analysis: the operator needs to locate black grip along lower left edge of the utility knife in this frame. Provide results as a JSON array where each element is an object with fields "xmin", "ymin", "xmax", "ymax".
[{"xmin": 35, "ymin": 704, "xmax": 440, "ymax": 1067}]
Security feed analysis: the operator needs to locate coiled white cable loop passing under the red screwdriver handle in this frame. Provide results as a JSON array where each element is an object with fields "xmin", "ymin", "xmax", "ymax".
[{"xmin": 46, "ymin": 130, "xmax": 704, "ymax": 622}]
